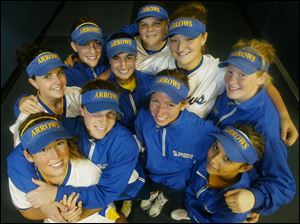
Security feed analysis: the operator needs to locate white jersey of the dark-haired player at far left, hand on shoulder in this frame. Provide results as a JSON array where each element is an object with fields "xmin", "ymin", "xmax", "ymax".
[{"xmin": 9, "ymin": 86, "xmax": 81, "ymax": 147}]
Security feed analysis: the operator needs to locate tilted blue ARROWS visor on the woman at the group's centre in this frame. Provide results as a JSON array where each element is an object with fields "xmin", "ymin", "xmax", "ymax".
[{"xmin": 147, "ymin": 76, "xmax": 189, "ymax": 104}]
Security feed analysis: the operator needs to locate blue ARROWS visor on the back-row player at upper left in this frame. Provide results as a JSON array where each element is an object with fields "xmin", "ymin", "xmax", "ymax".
[{"xmin": 71, "ymin": 23, "xmax": 103, "ymax": 46}]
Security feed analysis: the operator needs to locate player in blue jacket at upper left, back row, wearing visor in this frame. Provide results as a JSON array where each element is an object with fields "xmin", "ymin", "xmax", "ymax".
[{"xmin": 65, "ymin": 18, "xmax": 108, "ymax": 87}]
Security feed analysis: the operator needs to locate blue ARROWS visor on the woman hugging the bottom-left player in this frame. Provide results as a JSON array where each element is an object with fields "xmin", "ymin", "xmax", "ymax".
[{"xmin": 81, "ymin": 89, "xmax": 123, "ymax": 115}]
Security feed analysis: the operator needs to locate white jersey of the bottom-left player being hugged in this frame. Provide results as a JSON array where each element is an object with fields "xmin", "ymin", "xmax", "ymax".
[{"xmin": 8, "ymin": 159, "xmax": 114, "ymax": 223}]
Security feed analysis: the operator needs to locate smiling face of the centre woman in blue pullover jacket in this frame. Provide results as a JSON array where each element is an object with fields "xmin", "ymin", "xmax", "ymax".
[{"xmin": 150, "ymin": 92, "xmax": 185, "ymax": 126}]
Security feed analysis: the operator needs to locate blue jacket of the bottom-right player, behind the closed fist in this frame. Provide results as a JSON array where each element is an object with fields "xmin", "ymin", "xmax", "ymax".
[{"xmin": 185, "ymin": 160, "xmax": 251, "ymax": 223}]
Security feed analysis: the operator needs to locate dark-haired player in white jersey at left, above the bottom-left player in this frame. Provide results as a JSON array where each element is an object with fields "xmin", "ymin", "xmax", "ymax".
[{"xmin": 10, "ymin": 45, "xmax": 80, "ymax": 146}]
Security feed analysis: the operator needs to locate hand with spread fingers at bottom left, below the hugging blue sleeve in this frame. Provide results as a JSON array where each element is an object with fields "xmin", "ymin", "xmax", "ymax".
[{"xmin": 61, "ymin": 192, "xmax": 82, "ymax": 222}]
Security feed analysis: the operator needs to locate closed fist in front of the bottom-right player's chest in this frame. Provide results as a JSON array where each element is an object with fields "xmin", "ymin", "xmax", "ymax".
[{"xmin": 224, "ymin": 189, "xmax": 255, "ymax": 213}]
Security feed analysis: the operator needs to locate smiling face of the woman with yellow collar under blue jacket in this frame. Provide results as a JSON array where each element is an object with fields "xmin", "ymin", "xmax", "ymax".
[{"xmin": 109, "ymin": 53, "xmax": 136, "ymax": 84}]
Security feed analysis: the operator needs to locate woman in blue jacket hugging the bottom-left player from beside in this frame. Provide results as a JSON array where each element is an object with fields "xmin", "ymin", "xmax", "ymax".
[{"xmin": 22, "ymin": 80, "xmax": 145, "ymax": 222}]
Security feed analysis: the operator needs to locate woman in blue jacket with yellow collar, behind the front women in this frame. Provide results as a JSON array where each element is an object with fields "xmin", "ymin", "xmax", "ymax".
[{"xmin": 106, "ymin": 33, "xmax": 154, "ymax": 133}]
